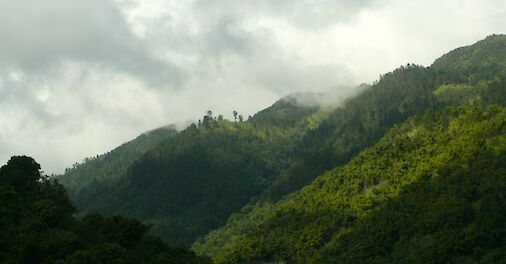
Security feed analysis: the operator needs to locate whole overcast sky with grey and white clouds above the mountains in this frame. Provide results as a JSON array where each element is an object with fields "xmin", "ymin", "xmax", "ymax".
[{"xmin": 0, "ymin": 0, "xmax": 506, "ymax": 174}]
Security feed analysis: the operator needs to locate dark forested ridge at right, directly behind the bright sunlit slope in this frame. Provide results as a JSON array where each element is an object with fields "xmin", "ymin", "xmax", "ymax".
[{"xmin": 263, "ymin": 35, "xmax": 506, "ymax": 201}]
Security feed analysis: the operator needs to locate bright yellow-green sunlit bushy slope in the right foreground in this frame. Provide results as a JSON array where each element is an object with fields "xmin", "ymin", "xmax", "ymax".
[{"xmin": 202, "ymin": 106, "xmax": 506, "ymax": 263}]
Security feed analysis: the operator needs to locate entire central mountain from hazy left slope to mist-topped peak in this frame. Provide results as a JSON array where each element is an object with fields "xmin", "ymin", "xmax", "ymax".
[{"xmin": 61, "ymin": 94, "xmax": 332, "ymax": 245}]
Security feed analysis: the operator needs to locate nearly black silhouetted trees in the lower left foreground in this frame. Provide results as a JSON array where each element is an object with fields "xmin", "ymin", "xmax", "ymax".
[{"xmin": 0, "ymin": 156, "xmax": 208, "ymax": 263}]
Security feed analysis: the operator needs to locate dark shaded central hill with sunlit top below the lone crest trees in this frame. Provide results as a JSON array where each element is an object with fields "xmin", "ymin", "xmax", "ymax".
[{"xmin": 86, "ymin": 121, "xmax": 308, "ymax": 245}]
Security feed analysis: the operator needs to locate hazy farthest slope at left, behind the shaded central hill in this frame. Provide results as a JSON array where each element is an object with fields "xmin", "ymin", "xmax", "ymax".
[{"xmin": 58, "ymin": 126, "xmax": 178, "ymax": 208}]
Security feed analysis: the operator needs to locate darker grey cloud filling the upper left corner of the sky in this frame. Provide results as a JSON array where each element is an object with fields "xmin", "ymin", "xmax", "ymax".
[{"xmin": 0, "ymin": 0, "xmax": 180, "ymax": 85}]
